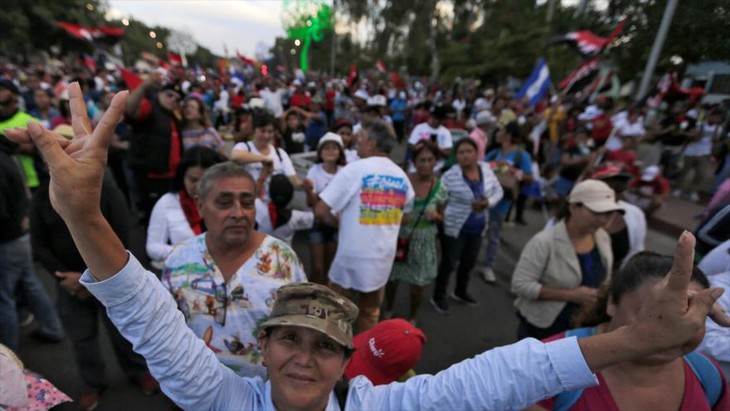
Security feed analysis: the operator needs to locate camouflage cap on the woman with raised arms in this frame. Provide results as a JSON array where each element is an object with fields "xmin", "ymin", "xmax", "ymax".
[{"xmin": 261, "ymin": 283, "xmax": 358, "ymax": 348}]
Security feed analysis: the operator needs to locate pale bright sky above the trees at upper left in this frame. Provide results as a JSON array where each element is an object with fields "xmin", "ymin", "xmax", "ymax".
[{"xmin": 108, "ymin": 0, "xmax": 285, "ymax": 57}]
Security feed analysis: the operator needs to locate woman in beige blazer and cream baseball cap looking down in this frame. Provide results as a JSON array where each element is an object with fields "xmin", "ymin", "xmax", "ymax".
[{"xmin": 512, "ymin": 180, "xmax": 622, "ymax": 339}]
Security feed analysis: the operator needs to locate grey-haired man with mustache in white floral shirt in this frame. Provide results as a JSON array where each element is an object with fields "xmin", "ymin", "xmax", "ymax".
[{"xmin": 162, "ymin": 162, "xmax": 307, "ymax": 376}]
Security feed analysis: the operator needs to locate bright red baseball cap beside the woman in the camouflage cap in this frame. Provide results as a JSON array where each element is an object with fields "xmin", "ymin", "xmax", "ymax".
[{"xmin": 345, "ymin": 318, "xmax": 426, "ymax": 385}]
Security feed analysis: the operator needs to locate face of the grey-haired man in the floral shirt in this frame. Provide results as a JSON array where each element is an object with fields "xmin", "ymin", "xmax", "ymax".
[{"xmin": 197, "ymin": 177, "xmax": 256, "ymax": 246}]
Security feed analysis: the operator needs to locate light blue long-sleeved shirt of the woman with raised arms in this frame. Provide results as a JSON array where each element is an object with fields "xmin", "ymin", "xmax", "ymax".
[{"xmin": 81, "ymin": 254, "xmax": 598, "ymax": 411}]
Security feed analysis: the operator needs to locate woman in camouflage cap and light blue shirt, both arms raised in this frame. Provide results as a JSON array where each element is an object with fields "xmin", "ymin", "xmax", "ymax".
[{"xmin": 6, "ymin": 84, "xmax": 730, "ymax": 411}]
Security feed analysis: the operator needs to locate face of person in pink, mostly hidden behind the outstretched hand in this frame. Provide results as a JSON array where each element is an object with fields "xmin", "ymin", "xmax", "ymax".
[{"xmin": 606, "ymin": 278, "xmax": 705, "ymax": 365}]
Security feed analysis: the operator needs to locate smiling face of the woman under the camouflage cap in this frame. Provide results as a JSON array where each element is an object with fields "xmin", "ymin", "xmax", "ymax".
[{"xmin": 259, "ymin": 326, "xmax": 348, "ymax": 410}]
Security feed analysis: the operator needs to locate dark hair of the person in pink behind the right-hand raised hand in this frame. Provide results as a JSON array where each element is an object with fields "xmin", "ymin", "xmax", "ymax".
[{"xmin": 573, "ymin": 251, "xmax": 710, "ymax": 327}]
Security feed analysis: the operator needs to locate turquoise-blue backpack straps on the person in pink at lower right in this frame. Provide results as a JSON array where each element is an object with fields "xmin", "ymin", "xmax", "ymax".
[{"xmin": 553, "ymin": 327, "xmax": 723, "ymax": 411}]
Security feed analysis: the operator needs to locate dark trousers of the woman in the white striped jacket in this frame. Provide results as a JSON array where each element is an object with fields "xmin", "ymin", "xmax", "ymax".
[{"xmin": 433, "ymin": 233, "xmax": 482, "ymax": 300}]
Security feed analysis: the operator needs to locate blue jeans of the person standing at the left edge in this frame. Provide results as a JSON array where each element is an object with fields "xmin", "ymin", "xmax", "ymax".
[{"xmin": 0, "ymin": 234, "xmax": 63, "ymax": 351}]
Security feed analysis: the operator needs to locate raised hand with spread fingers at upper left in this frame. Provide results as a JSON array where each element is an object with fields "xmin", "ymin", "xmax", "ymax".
[{"xmin": 5, "ymin": 83, "xmax": 129, "ymax": 222}]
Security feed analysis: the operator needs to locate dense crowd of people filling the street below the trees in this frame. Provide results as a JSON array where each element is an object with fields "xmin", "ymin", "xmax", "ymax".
[{"xmin": 0, "ymin": 54, "xmax": 730, "ymax": 410}]
